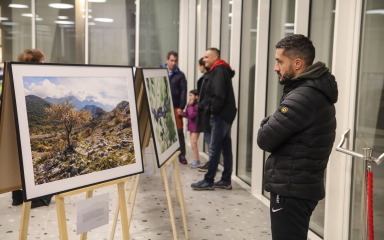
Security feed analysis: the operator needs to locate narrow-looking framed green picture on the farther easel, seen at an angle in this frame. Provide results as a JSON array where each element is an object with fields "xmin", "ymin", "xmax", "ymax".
[{"xmin": 142, "ymin": 68, "xmax": 180, "ymax": 168}]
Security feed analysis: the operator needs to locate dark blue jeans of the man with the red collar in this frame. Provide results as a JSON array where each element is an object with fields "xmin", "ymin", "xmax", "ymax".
[{"xmin": 204, "ymin": 117, "xmax": 233, "ymax": 183}]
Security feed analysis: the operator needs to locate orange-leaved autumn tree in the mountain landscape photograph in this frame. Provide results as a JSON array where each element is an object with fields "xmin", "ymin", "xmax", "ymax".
[{"xmin": 45, "ymin": 97, "xmax": 92, "ymax": 151}]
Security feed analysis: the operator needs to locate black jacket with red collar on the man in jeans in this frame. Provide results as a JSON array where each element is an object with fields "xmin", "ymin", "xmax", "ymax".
[{"xmin": 197, "ymin": 60, "xmax": 237, "ymax": 132}]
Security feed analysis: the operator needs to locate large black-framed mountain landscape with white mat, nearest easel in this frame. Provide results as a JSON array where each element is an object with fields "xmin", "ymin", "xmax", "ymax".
[{"xmin": 10, "ymin": 63, "xmax": 143, "ymax": 201}]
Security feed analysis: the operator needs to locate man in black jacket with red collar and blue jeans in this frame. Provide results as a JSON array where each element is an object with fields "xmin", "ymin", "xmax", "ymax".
[{"xmin": 191, "ymin": 48, "xmax": 237, "ymax": 190}]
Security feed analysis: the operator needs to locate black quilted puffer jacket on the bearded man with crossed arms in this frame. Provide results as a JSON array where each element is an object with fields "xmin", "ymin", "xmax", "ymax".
[{"xmin": 257, "ymin": 62, "xmax": 338, "ymax": 200}]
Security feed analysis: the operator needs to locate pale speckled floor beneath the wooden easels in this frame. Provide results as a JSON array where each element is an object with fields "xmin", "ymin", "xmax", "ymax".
[{"xmin": 0, "ymin": 147, "xmax": 271, "ymax": 240}]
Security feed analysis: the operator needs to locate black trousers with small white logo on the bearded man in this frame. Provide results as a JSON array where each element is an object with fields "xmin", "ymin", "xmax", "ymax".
[{"xmin": 269, "ymin": 193, "xmax": 318, "ymax": 240}]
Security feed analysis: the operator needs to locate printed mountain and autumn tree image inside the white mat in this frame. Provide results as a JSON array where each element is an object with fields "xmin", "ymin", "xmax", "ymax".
[{"xmin": 23, "ymin": 77, "xmax": 135, "ymax": 184}]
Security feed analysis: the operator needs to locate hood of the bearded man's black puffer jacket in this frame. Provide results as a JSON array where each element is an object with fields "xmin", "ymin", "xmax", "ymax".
[{"xmin": 291, "ymin": 62, "xmax": 338, "ymax": 103}]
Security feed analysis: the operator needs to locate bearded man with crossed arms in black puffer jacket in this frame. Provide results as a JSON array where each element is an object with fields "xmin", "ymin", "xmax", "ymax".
[{"xmin": 257, "ymin": 34, "xmax": 338, "ymax": 240}]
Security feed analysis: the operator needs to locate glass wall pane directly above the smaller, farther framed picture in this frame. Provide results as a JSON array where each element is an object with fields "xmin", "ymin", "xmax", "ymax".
[{"xmin": 139, "ymin": 0, "xmax": 179, "ymax": 67}]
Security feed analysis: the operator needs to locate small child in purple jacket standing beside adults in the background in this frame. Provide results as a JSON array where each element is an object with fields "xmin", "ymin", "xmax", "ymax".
[{"xmin": 183, "ymin": 89, "xmax": 200, "ymax": 168}]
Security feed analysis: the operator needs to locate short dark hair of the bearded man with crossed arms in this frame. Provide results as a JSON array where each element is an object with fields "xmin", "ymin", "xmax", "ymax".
[{"xmin": 276, "ymin": 34, "xmax": 315, "ymax": 66}]
